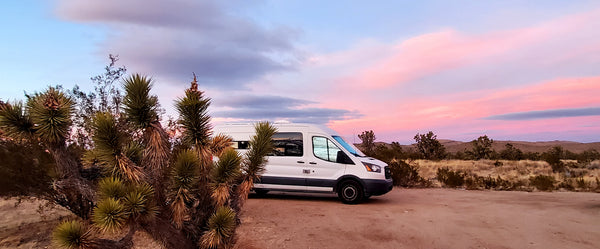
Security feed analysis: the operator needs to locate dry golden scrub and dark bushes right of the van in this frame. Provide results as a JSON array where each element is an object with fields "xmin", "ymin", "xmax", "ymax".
[{"xmin": 359, "ymin": 131, "xmax": 600, "ymax": 192}]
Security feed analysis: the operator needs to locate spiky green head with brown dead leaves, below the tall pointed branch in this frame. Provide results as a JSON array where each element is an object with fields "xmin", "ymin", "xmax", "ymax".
[{"xmin": 171, "ymin": 150, "xmax": 200, "ymax": 228}]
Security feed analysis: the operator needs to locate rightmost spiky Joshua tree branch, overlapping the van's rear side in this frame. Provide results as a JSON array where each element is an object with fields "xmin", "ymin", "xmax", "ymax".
[{"xmin": 238, "ymin": 122, "xmax": 277, "ymax": 202}]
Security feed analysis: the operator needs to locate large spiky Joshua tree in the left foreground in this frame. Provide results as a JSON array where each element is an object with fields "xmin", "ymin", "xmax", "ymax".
[{"xmin": 0, "ymin": 75, "xmax": 275, "ymax": 248}]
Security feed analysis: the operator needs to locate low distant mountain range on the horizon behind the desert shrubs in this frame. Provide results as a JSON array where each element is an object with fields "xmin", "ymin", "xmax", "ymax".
[{"xmin": 368, "ymin": 139, "xmax": 600, "ymax": 153}]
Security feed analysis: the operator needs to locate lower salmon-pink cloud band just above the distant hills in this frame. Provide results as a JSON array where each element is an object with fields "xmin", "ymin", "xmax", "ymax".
[{"xmin": 330, "ymin": 74, "xmax": 600, "ymax": 141}]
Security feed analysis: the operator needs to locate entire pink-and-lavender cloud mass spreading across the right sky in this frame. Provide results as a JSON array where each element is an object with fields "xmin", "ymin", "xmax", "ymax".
[{"xmin": 294, "ymin": 10, "xmax": 600, "ymax": 141}]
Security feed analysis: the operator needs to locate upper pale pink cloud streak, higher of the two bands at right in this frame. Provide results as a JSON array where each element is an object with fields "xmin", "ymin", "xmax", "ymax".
[{"xmin": 324, "ymin": 10, "xmax": 600, "ymax": 89}]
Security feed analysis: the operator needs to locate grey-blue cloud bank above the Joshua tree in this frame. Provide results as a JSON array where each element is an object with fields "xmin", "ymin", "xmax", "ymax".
[{"xmin": 56, "ymin": 0, "xmax": 300, "ymax": 89}]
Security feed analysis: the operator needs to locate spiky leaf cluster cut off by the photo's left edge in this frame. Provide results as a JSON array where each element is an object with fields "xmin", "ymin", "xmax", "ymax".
[{"xmin": 0, "ymin": 102, "xmax": 35, "ymax": 140}]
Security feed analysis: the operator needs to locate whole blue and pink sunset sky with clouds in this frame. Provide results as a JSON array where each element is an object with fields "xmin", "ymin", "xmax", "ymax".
[{"xmin": 0, "ymin": 0, "xmax": 600, "ymax": 144}]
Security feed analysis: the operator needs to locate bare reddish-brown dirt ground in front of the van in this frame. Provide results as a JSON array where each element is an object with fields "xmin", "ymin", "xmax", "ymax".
[{"xmin": 238, "ymin": 189, "xmax": 600, "ymax": 248}]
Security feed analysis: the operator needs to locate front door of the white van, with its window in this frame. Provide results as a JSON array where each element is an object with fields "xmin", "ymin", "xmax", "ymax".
[{"xmin": 306, "ymin": 134, "xmax": 346, "ymax": 192}]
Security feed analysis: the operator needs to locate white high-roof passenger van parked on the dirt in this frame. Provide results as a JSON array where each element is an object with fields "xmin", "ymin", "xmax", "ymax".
[{"xmin": 214, "ymin": 123, "xmax": 393, "ymax": 204}]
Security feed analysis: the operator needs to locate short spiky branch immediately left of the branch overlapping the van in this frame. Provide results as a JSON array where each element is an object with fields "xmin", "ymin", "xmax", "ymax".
[{"xmin": 211, "ymin": 148, "xmax": 242, "ymax": 206}]
